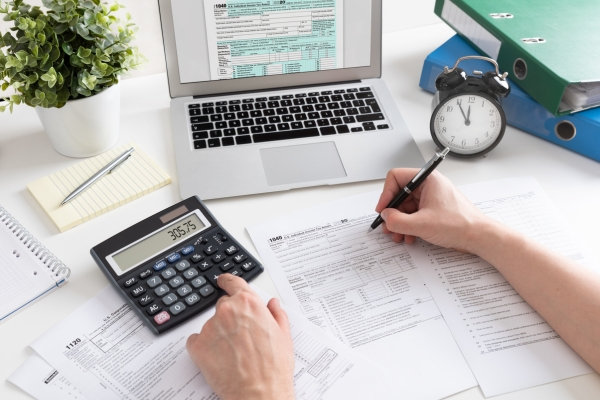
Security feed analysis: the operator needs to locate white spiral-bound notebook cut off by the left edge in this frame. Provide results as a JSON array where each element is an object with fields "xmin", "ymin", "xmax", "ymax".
[{"xmin": 0, "ymin": 206, "xmax": 71, "ymax": 321}]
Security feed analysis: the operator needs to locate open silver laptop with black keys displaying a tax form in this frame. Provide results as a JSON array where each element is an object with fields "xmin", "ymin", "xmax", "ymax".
[{"xmin": 158, "ymin": 0, "xmax": 423, "ymax": 200}]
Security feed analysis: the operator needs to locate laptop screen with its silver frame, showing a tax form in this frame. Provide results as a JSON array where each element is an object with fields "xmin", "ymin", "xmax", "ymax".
[{"xmin": 159, "ymin": 0, "xmax": 381, "ymax": 97}]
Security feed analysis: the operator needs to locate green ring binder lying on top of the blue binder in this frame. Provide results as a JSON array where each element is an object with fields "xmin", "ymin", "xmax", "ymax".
[{"xmin": 434, "ymin": 0, "xmax": 600, "ymax": 115}]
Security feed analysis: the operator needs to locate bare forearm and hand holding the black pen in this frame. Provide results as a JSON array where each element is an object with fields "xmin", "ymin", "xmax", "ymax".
[{"xmin": 376, "ymin": 169, "xmax": 600, "ymax": 372}]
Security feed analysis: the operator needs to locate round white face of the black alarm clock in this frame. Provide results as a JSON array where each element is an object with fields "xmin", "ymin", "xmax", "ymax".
[{"xmin": 430, "ymin": 93, "xmax": 506, "ymax": 157}]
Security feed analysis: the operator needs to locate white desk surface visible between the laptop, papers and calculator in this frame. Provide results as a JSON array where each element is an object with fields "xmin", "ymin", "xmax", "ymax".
[{"xmin": 0, "ymin": 23, "xmax": 600, "ymax": 400}]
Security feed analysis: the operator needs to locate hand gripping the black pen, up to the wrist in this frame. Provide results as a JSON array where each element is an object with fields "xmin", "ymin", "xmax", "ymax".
[{"xmin": 375, "ymin": 168, "xmax": 487, "ymax": 252}]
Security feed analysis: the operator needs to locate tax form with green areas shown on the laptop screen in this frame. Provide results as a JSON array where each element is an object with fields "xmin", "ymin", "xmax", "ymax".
[{"xmin": 204, "ymin": 0, "xmax": 344, "ymax": 80}]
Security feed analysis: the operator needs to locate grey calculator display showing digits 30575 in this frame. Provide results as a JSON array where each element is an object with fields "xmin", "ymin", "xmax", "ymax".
[{"xmin": 112, "ymin": 212, "xmax": 207, "ymax": 275}]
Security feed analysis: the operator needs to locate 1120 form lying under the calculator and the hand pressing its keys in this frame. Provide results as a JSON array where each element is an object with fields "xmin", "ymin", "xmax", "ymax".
[{"xmin": 25, "ymin": 287, "xmax": 395, "ymax": 400}]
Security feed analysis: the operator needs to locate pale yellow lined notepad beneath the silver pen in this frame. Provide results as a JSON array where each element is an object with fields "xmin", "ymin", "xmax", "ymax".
[{"xmin": 27, "ymin": 143, "xmax": 171, "ymax": 232}]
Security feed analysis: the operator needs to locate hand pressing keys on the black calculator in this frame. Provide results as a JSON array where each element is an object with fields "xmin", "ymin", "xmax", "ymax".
[{"xmin": 186, "ymin": 274, "xmax": 294, "ymax": 400}]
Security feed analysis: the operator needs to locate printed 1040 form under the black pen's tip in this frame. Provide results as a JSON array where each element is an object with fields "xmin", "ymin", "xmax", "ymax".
[{"xmin": 248, "ymin": 192, "xmax": 476, "ymax": 399}]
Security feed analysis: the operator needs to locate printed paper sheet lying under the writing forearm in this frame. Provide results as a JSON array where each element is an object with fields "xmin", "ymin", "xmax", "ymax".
[{"xmin": 409, "ymin": 178, "xmax": 591, "ymax": 396}]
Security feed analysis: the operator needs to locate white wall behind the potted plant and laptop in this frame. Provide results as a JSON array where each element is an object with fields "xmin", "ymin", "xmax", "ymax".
[{"xmin": 0, "ymin": 0, "xmax": 440, "ymax": 78}]
